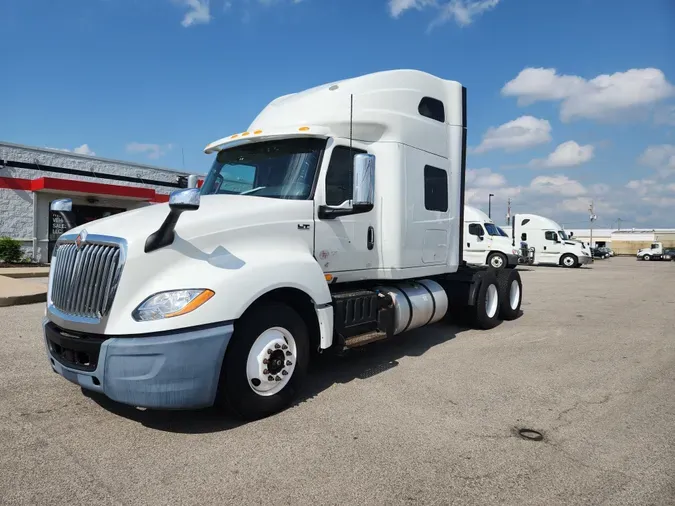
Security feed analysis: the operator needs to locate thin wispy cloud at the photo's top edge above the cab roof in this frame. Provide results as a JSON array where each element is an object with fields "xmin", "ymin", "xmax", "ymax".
[{"xmin": 388, "ymin": 0, "xmax": 501, "ymax": 28}]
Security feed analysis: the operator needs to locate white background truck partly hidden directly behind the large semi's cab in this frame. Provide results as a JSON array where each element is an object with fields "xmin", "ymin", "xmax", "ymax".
[{"xmin": 463, "ymin": 206, "xmax": 520, "ymax": 269}]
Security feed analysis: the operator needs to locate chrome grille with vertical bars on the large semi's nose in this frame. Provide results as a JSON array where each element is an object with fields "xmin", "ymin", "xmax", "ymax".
[{"xmin": 50, "ymin": 242, "xmax": 123, "ymax": 318}]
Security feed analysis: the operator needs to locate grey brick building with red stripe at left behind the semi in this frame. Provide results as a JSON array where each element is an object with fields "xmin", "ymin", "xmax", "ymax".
[{"xmin": 0, "ymin": 142, "xmax": 201, "ymax": 262}]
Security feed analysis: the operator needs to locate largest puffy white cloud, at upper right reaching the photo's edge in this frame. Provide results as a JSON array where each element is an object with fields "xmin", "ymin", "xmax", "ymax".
[{"xmin": 502, "ymin": 67, "xmax": 675, "ymax": 122}]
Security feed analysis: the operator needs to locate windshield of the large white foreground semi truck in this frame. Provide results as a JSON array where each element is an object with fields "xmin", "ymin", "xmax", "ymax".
[{"xmin": 201, "ymin": 138, "xmax": 326, "ymax": 200}]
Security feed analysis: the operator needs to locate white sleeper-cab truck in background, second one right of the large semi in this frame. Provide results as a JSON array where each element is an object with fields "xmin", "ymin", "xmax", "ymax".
[{"xmin": 511, "ymin": 214, "xmax": 593, "ymax": 267}]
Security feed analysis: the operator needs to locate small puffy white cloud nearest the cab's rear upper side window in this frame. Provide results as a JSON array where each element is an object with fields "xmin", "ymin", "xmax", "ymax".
[{"xmin": 473, "ymin": 116, "xmax": 551, "ymax": 153}]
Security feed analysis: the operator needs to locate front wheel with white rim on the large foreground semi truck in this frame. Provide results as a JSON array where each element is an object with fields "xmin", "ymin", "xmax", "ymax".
[{"xmin": 218, "ymin": 303, "xmax": 310, "ymax": 420}]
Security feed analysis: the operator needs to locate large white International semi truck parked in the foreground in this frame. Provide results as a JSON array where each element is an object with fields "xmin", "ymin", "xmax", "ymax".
[{"xmin": 43, "ymin": 70, "xmax": 522, "ymax": 419}]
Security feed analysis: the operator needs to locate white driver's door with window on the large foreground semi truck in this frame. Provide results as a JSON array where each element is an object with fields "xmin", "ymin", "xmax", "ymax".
[{"xmin": 314, "ymin": 145, "xmax": 380, "ymax": 275}]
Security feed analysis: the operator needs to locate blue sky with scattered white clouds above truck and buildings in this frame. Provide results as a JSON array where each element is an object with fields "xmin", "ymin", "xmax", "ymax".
[{"xmin": 0, "ymin": 0, "xmax": 675, "ymax": 227}]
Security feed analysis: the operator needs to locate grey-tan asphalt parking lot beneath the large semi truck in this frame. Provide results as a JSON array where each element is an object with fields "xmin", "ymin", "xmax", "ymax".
[{"xmin": 0, "ymin": 258, "xmax": 675, "ymax": 505}]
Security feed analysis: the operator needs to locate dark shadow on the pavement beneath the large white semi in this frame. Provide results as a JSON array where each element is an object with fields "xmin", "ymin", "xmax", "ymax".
[{"xmin": 82, "ymin": 323, "xmax": 465, "ymax": 434}]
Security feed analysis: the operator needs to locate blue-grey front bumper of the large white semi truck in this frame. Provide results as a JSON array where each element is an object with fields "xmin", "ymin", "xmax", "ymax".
[{"xmin": 43, "ymin": 319, "xmax": 234, "ymax": 409}]
